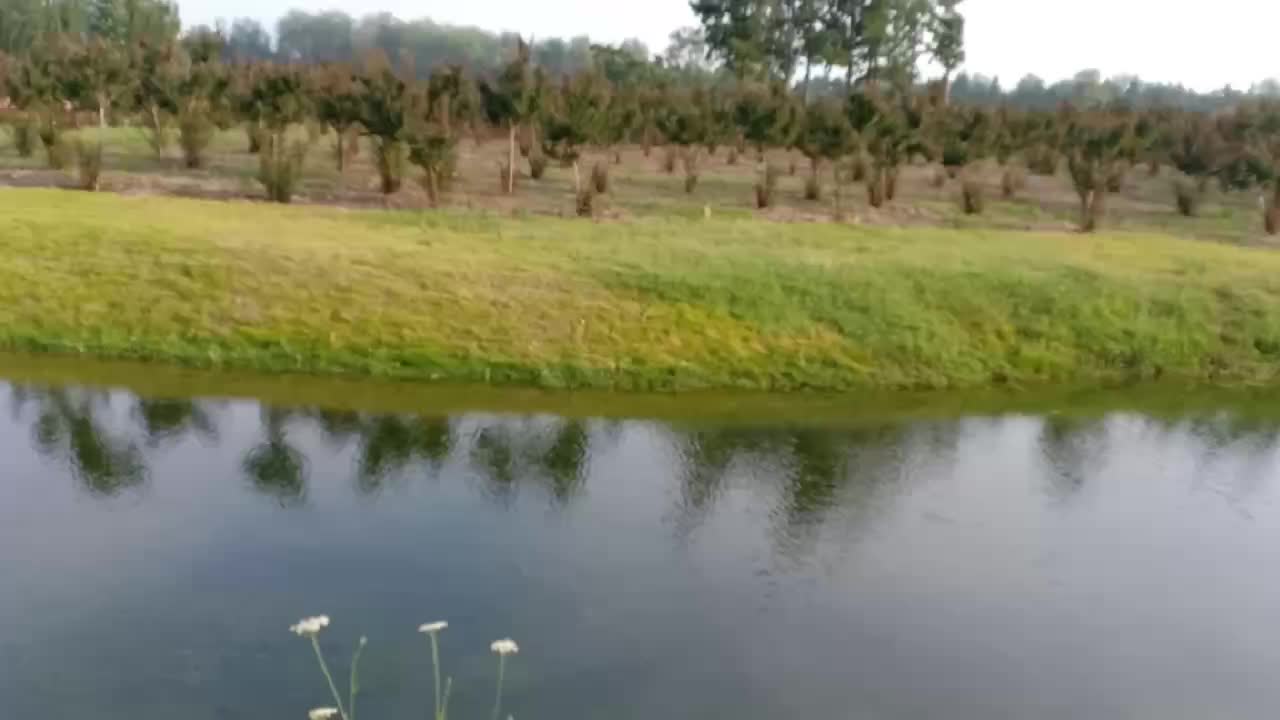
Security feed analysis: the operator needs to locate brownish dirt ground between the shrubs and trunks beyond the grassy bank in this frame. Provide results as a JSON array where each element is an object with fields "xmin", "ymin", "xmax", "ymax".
[{"xmin": 0, "ymin": 122, "xmax": 1266, "ymax": 245}]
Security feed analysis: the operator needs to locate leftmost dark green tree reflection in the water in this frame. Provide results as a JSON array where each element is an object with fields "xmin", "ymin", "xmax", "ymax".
[{"xmin": 15, "ymin": 388, "xmax": 147, "ymax": 496}]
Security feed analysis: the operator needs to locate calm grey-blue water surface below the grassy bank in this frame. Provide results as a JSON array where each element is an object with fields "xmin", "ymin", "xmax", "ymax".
[{"xmin": 0, "ymin": 376, "xmax": 1280, "ymax": 720}]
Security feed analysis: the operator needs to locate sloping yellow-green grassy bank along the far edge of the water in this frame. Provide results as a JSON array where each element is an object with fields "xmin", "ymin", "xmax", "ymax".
[{"xmin": 0, "ymin": 184, "xmax": 1280, "ymax": 389}]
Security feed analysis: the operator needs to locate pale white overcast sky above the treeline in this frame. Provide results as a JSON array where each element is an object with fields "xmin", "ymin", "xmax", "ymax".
[{"xmin": 179, "ymin": 0, "xmax": 1280, "ymax": 90}]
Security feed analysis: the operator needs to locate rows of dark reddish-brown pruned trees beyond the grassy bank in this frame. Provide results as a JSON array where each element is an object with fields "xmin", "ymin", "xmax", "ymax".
[{"xmin": 5, "ymin": 32, "xmax": 1280, "ymax": 232}]
